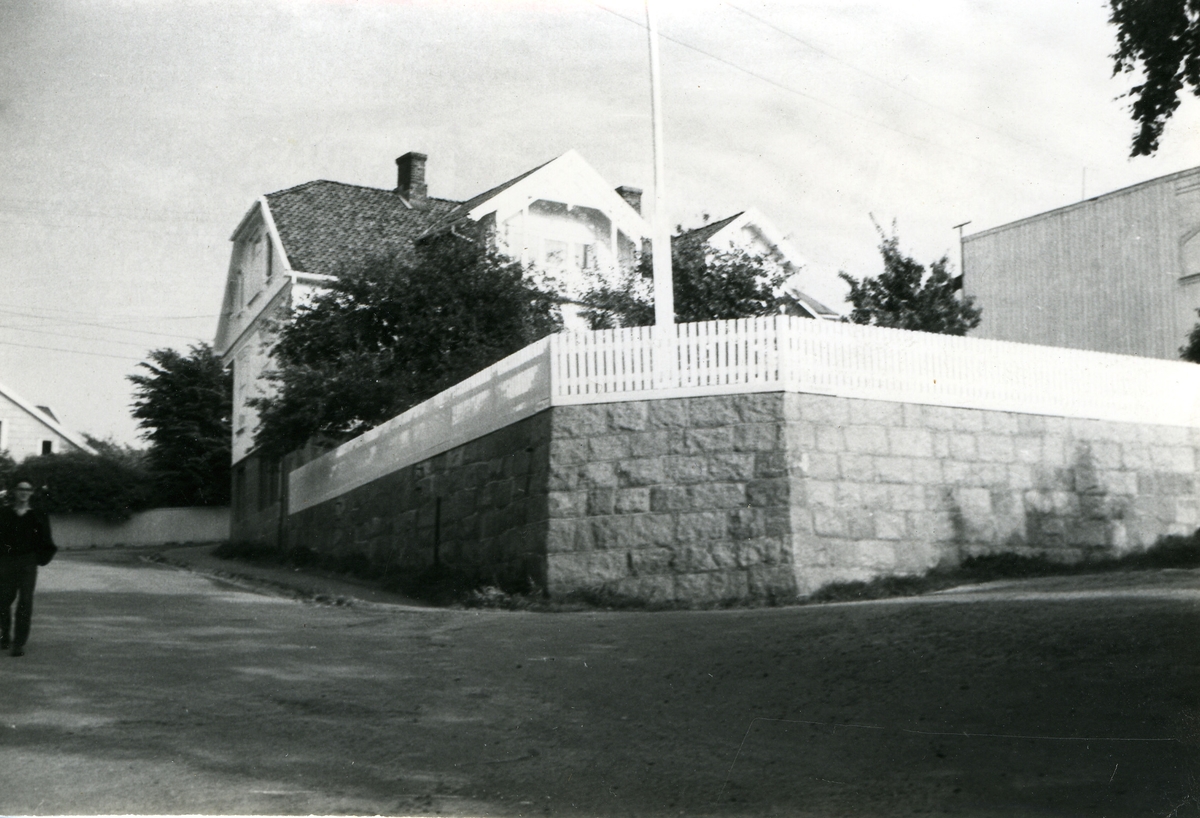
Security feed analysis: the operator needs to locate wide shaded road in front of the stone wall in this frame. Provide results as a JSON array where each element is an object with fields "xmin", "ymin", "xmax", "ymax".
[{"xmin": 0, "ymin": 552, "xmax": 1200, "ymax": 816}]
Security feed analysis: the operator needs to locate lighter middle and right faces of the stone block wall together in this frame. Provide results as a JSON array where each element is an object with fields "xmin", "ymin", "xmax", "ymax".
[{"xmin": 546, "ymin": 393, "xmax": 1200, "ymax": 601}]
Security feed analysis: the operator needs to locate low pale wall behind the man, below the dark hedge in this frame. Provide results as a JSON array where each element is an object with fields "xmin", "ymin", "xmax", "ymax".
[{"xmin": 50, "ymin": 506, "xmax": 229, "ymax": 548}]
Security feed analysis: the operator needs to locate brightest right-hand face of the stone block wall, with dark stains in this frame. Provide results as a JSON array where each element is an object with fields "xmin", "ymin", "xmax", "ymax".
[{"xmin": 786, "ymin": 395, "xmax": 1200, "ymax": 593}]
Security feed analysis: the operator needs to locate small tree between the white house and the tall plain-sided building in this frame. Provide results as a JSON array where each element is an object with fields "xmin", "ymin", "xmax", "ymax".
[{"xmin": 838, "ymin": 224, "xmax": 980, "ymax": 335}]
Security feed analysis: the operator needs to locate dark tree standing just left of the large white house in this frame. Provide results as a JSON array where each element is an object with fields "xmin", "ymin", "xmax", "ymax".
[{"xmin": 128, "ymin": 343, "xmax": 233, "ymax": 506}]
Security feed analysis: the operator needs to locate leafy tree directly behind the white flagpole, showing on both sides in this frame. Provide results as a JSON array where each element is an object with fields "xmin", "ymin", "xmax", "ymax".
[{"xmin": 581, "ymin": 228, "xmax": 786, "ymax": 330}]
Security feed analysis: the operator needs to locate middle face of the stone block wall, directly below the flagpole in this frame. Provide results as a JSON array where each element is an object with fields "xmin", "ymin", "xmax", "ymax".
[{"xmin": 546, "ymin": 392, "xmax": 798, "ymax": 601}]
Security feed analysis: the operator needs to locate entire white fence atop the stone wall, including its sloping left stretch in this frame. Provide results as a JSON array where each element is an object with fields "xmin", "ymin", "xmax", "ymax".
[{"xmin": 289, "ymin": 315, "xmax": 1200, "ymax": 512}]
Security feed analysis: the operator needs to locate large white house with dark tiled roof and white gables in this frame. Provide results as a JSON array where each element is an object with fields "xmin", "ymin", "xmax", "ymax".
[{"xmin": 214, "ymin": 151, "xmax": 833, "ymax": 536}]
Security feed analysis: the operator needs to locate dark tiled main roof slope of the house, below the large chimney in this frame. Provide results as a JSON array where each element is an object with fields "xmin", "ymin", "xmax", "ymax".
[{"xmin": 266, "ymin": 180, "xmax": 458, "ymax": 276}]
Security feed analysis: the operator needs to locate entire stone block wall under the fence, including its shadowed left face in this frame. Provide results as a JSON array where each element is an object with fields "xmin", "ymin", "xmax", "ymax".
[{"xmin": 287, "ymin": 392, "xmax": 1200, "ymax": 601}]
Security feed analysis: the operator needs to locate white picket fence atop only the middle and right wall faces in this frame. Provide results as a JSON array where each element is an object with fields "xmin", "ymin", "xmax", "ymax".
[{"xmin": 548, "ymin": 315, "xmax": 1200, "ymax": 426}]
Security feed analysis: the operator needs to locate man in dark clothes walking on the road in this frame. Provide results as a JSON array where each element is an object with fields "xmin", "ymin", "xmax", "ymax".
[{"xmin": 0, "ymin": 481, "xmax": 58, "ymax": 656}]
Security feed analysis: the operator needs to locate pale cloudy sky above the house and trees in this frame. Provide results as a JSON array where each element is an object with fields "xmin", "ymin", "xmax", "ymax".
[{"xmin": 0, "ymin": 0, "xmax": 1200, "ymax": 445}]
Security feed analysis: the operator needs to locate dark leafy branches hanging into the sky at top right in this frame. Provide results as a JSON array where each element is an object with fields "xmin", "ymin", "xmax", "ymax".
[{"xmin": 1109, "ymin": 0, "xmax": 1200, "ymax": 156}]
